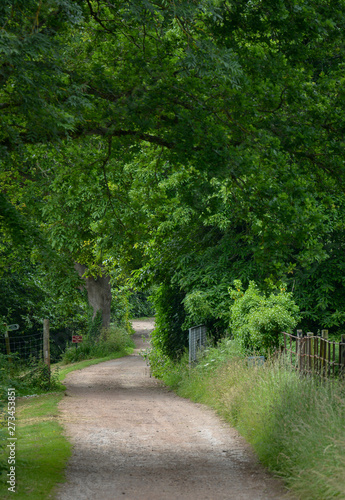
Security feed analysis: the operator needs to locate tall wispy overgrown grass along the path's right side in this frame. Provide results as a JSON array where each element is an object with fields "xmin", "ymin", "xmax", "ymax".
[{"xmin": 155, "ymin": 341, "xmax": 345, "ymax": 500}]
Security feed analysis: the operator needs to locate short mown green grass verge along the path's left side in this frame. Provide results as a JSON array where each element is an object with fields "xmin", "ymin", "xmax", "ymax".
[{"xmin": 0, "ymin": 348, "xmax": 133, "ymax": 500}]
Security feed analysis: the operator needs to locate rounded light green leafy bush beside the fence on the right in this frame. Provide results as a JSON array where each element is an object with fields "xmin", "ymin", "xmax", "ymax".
[{"xmin": 229, "ymin": 280, "xmax": 300, "ymax": 355}]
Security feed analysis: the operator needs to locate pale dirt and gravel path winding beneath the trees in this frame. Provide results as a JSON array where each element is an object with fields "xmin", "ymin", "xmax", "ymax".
[{"xmin": 57, "ymin": 321, "xmax": 285, "ymax": 500}]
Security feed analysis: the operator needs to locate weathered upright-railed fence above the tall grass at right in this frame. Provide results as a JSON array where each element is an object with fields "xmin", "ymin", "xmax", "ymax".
[{"xmin": 283, "ymin": 330, "xmax": 345, "ymax": 378}]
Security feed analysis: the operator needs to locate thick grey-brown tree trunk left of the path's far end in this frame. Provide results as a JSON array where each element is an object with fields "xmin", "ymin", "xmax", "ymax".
[{"xmin": 74, "ymin": 263, "xmax": 111, "ymax": 328}]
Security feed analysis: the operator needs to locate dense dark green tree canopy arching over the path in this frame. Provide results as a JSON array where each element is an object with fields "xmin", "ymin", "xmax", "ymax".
[{"xmin": 0, "ymin": 0, "xmax": 345, "ymax": 356}]
